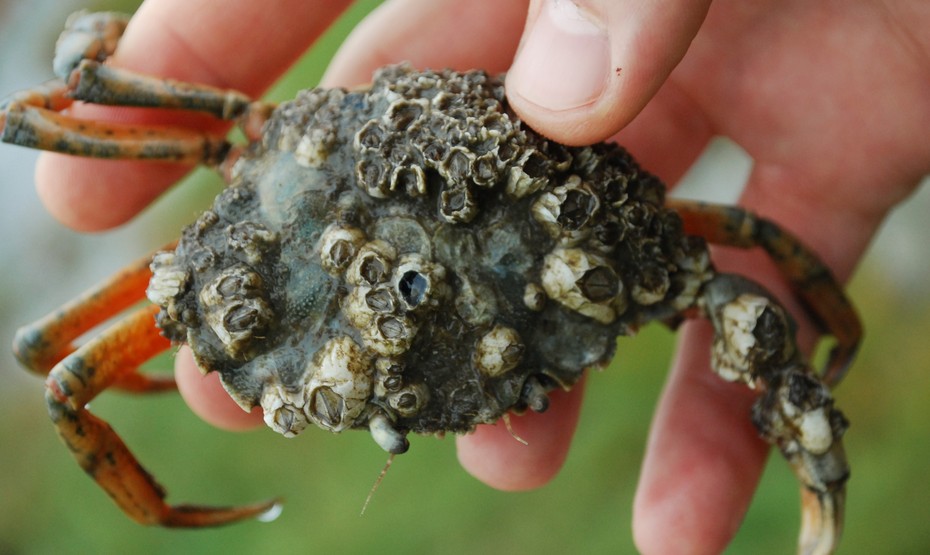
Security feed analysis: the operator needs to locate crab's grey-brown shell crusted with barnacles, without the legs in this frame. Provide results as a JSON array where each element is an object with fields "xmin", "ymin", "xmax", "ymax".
[{"xmin": 149, "ymin": 66, "xmax": 710, "ymax": 452}]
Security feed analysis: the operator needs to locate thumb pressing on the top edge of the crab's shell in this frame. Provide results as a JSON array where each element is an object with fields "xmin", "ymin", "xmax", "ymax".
[{"xmin": 507, "ymin": 0, "xmax": 710, "ymax": 145}]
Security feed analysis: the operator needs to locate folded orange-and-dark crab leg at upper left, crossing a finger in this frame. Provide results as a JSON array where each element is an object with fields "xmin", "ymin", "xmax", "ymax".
[{"xmin": 0, "ymin": 13, "xmax": 274, "ymax": 166}]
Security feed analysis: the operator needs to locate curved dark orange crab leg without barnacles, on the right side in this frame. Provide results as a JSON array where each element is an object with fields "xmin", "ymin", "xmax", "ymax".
[{"xmin": 668, "ymin": 199, "xmax": 862, "ymax": 386}]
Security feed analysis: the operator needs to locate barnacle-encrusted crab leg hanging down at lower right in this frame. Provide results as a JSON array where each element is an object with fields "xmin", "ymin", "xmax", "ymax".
[{"xmin": 702, "ymin": 274, "xmax": 849, "ymax": 555}]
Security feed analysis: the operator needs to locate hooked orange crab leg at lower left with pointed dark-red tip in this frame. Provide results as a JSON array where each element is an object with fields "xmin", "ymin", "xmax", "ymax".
[{"xmin": 45, "ymin": 305, "xmax": 276, "ymax": 527}]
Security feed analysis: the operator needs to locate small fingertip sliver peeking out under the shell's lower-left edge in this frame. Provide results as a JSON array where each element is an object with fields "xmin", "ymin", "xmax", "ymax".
[{"xmin": 174, "ymin": 347, "xmax": 263, "ymax": 431}]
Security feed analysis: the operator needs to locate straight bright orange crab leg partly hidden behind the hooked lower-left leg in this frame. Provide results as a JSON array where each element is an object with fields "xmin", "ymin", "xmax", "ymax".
[{"xmin": 13, "ymin": 245, "xmax": 175, "ymax": 392}]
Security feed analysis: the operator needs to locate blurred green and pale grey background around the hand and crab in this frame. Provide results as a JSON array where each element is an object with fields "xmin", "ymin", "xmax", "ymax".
[{"xmin": 0, "ymin": 0, "xmax": 930, "ymax": 555}]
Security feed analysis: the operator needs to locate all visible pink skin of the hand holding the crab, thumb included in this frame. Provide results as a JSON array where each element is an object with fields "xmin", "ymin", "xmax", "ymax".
[{"xmin": 29, "ymin": 0, "xmax": 930, "ymax": 553}]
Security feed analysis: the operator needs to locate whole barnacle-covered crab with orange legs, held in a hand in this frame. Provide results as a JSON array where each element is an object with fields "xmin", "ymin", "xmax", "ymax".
[{"xmin": 0, "ymin": 13, "xmax": 861, "ymax": 554}]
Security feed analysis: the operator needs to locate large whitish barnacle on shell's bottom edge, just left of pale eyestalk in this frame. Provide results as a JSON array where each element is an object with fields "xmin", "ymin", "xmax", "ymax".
[{"xmin": 304, "ymin": 336, "xmax": 372, "ymax": 432}]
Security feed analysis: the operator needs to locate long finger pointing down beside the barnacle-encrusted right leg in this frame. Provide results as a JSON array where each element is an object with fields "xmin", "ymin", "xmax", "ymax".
[{"xmin": 633, "ymin": 322, "xmax": 769, "ymax": 555}]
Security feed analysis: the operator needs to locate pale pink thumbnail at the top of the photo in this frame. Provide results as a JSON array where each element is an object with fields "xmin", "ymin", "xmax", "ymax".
[{"xmin": 507, "ymin": 0, "xmax": 610, "ymax": 111}]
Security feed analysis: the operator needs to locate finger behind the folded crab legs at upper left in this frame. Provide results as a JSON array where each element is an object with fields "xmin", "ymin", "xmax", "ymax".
[{"xmin": 36, "ymin": 0, "xmax": 349, "ymax": 231}]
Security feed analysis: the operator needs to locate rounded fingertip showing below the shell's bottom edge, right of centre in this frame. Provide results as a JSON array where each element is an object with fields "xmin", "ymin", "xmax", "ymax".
[{"xmin": 456, "ymin": 383, "xmax": 584, "ymax": 491}]
